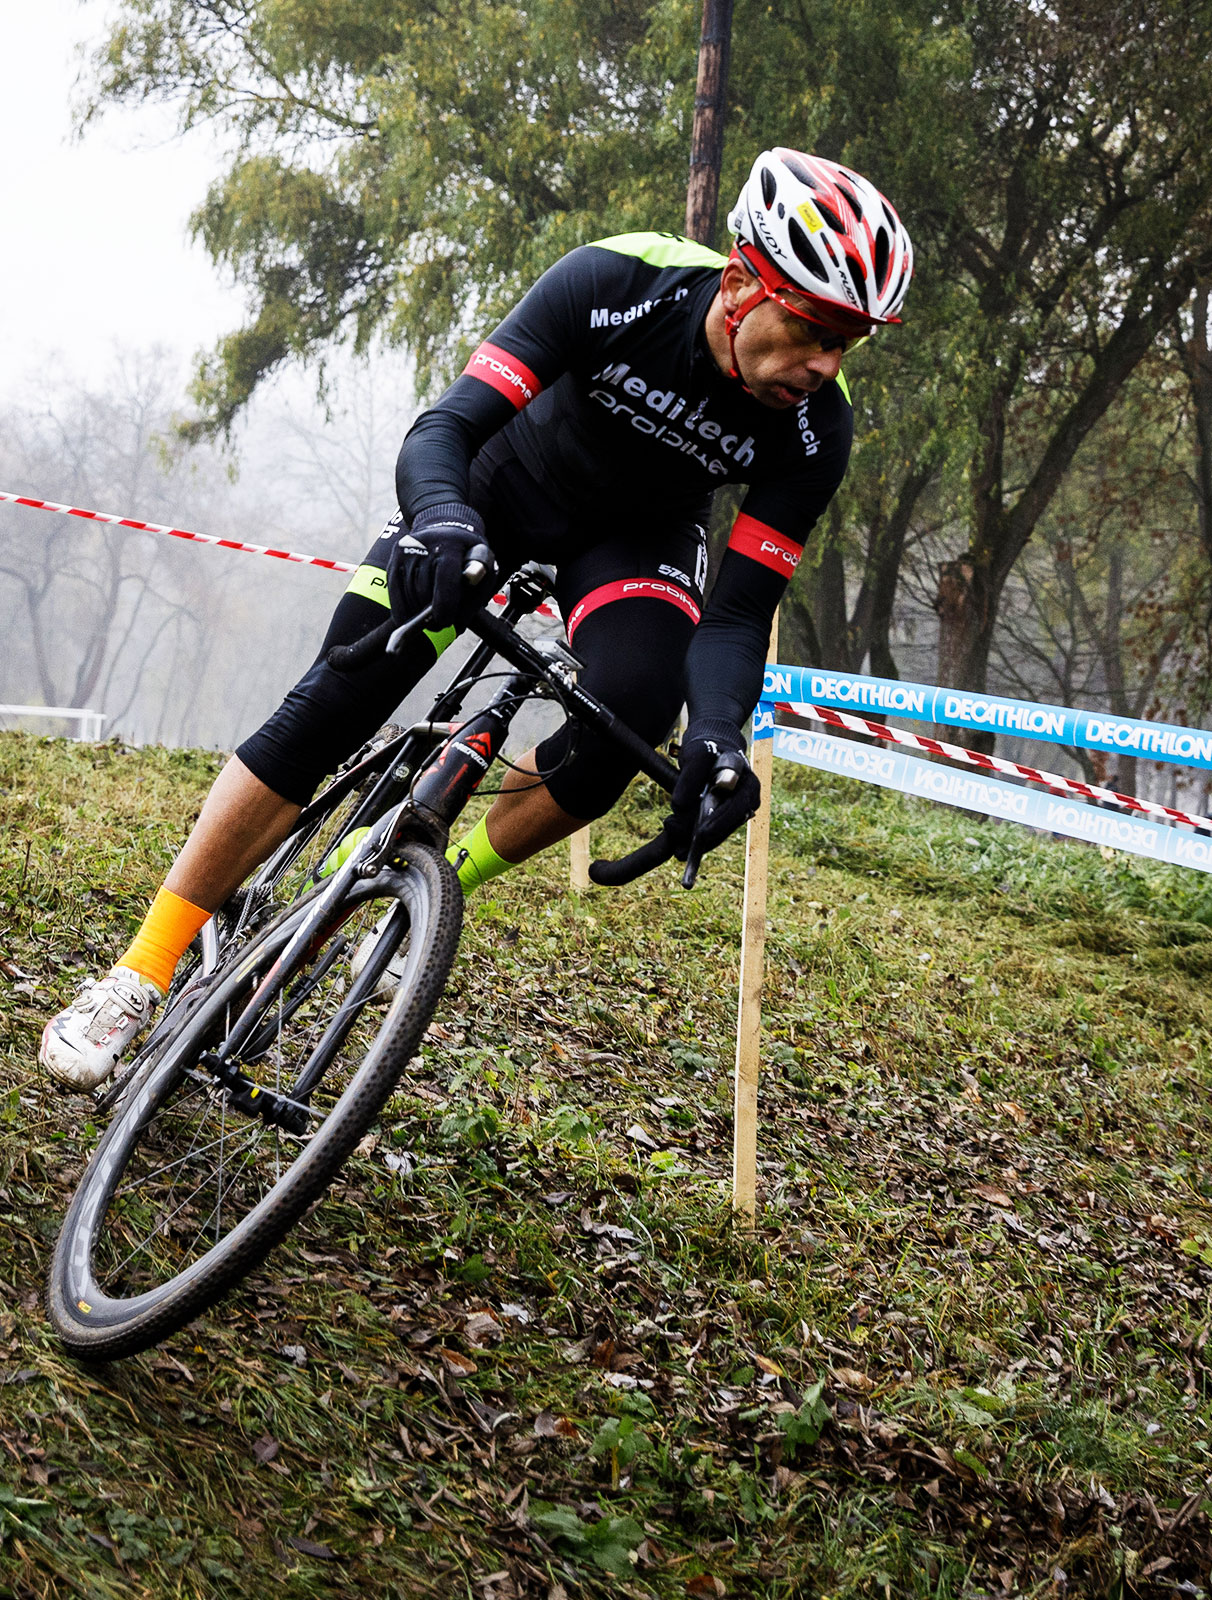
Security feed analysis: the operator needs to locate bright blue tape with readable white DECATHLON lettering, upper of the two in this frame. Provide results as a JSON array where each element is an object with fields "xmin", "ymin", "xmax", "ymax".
[{"xmin": 755, "ymin": 666, "xmax": 1212, "ymax": 766}]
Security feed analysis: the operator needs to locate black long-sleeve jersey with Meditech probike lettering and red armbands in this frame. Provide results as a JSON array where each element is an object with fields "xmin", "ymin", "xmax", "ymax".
[{"xmin": 397, "ymin": 234, "xmax": 852, "ymax": 723}]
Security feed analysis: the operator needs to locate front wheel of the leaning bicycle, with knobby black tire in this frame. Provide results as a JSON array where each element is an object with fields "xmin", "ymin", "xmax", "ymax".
[{"xmin": 46, "ymin": 843, "xmax": 462, "ymax": 1360}]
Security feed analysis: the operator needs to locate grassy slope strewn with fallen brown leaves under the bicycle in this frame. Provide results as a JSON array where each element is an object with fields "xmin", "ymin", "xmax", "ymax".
[{"xmin": 0, "ymin": 734, "xmax": 1212, "ymax": 1600}]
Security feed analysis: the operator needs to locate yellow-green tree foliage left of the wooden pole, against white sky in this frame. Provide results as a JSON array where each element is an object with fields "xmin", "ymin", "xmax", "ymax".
[{"xmin": 90, "ymin": 0, "xmax": 697, "ymax": 427}]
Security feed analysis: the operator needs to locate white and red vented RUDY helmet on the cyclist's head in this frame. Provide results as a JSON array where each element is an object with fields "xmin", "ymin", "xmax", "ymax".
[{"xmin": 728, "ymin": 147, "xmax": 913, "ymax": 338}]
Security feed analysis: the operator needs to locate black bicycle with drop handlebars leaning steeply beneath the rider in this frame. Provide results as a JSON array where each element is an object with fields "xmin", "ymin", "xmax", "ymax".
[{"xmin": 46, "ymin": 552, "xmax": 736, "ymax": 1360}]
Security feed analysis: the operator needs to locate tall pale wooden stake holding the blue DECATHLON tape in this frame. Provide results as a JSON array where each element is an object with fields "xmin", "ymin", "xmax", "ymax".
[{"xmin": 732, "ymin": 611, "xmax": 779, "ymax": 1227}]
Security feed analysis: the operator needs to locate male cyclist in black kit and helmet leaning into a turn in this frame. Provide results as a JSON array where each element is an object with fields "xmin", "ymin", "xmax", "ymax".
[{"xmin": 38, "ymin": 147, "xmax": 913, "ymax": 1090}]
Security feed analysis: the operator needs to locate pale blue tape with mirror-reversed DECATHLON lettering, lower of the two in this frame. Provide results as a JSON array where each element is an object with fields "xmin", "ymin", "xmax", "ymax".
[{"xmin": 772, "ymin": 728, "xmax": 1212, "ymax": 872}]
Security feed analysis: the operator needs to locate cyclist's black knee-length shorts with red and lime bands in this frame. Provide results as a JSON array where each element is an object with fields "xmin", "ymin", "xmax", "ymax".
[{"xmin": 237, "ymin": 435, "xmax": 707, "ymax": 821}]
